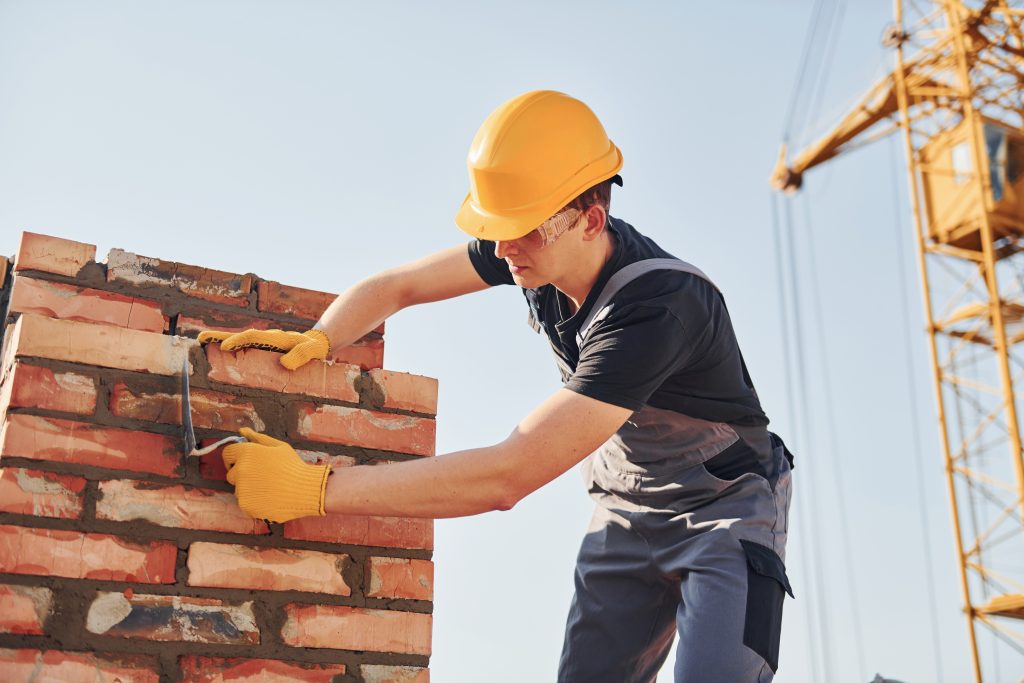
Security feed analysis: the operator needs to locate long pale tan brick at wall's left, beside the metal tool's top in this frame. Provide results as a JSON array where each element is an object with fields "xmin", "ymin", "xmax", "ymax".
[{"xmin": 9, "ymin": 313, "xmax": 197, "ymax": 375}]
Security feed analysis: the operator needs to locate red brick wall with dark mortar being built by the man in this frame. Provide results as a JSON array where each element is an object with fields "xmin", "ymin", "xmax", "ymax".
[{"xmin": 0, "ymin": 232, "xmax": 437, "ymax": 683}]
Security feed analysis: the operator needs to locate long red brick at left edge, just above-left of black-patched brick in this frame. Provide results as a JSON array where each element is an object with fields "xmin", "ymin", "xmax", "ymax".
[{"xmin": 0, "ymin": 525, "xmax": 177, "ymax": 584}]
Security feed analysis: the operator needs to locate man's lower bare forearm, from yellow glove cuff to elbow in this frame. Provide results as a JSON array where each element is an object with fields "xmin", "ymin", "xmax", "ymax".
[{"xmin": 325, "ymin": 445, "xmax": 524, "ymax": 519}]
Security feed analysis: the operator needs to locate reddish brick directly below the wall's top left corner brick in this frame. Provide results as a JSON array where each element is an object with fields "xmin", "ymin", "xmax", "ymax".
[{"xmin": 10, "ymin": 275, "xmax": 167, "ymax": 333}]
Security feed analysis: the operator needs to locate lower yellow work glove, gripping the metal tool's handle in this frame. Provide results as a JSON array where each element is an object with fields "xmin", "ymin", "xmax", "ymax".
[{"xmin": 224, "ymin": 427, "xmax": 331, "ymax": 522}]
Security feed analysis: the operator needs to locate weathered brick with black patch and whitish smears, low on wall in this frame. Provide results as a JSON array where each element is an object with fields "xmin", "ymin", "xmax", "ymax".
[{"xmin": 85, "ymin": 592, "xmax": 260, "ymax": 645}]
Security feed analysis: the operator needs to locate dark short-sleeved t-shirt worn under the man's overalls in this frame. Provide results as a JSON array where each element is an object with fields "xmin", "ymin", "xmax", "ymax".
[{"xmin": 469, "ymin": 217, "xmax": 768, "ymax": 425}]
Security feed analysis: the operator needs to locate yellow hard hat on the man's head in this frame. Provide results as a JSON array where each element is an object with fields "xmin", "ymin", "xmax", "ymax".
[{"xmin": 455, "ymin": 90, "xmax": 623, "ymax": 240}]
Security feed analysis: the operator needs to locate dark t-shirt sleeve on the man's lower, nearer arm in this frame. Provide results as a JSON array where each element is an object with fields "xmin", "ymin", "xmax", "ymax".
[{"xmin": 565, "ymin": 303, "xmax": 707, "ymax": 411}]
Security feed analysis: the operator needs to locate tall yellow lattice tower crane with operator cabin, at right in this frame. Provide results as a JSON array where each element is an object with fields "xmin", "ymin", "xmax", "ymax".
[{"xmin": 772, "ymin": 0, "xmax": 1024, "ymax": 683}]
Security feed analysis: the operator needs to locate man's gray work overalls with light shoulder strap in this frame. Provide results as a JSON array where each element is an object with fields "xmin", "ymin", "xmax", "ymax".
[{"xmin": 558, "ymin": 258, "xmax": 792, "ymax": 683}]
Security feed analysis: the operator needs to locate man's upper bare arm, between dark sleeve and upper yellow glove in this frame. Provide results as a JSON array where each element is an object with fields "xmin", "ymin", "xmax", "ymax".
[{"xmin": 315, "ymin": 244, "xmax": 489, "ymax": 348}]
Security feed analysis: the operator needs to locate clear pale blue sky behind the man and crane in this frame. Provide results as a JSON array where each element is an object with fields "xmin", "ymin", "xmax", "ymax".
[{"xmin": 0, "ymin": 0, "xmax": 1024, "ymax": 683}]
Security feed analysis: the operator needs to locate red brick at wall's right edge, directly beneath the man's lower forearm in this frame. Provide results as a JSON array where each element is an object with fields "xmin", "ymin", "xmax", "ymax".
[{"xmin": 285, "ymin": 514, "xmax": 434, "ymax": 550}]
